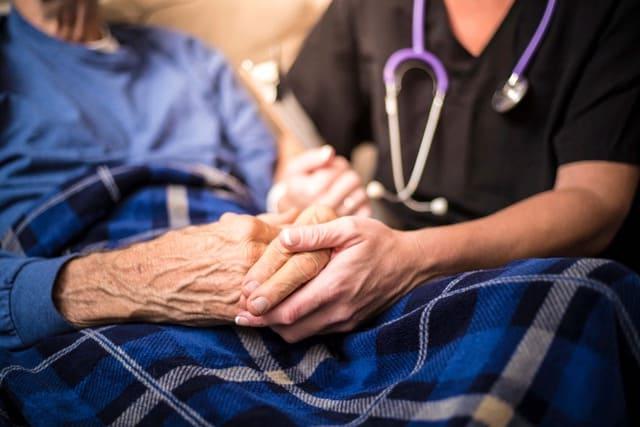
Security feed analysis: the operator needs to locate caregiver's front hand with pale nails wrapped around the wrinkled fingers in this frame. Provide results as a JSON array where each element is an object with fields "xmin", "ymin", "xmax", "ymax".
[{"xmin": 236, "ymin": 217, "xmax": 434, "ymax": 342}]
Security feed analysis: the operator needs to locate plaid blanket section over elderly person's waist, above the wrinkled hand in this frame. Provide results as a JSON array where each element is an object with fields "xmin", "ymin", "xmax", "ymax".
[{"xmin": 2, "ymin": 164, "xmax": 256, "ymax": 257}]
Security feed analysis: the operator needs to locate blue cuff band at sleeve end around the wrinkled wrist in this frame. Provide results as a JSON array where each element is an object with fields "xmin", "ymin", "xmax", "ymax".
[{"xmin": 11, "ymin": 256, "xmax": 74, "ymax": 346}]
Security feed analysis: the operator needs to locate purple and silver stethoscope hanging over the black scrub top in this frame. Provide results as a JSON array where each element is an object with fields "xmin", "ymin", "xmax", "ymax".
[{"xmin": 367, "ymin": 0, "xmax": 556, "ymax": 216}]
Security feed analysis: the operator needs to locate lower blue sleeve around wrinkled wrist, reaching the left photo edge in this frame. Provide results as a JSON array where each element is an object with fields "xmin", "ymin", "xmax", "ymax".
[{"xmin": 0, "ymin": 251, "xmax": 73, "ymax": 350}]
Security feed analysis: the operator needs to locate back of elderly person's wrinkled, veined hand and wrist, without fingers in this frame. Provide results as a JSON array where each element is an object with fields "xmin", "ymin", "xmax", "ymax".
[{"xmin": 54, "ymin": 214, "xmax": 291, "ymax": 327}]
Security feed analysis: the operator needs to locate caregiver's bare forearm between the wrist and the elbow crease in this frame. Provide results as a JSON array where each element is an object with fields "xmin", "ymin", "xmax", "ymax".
[{"xmin": 414, "ymin": 190, "xmax": 615, "ymax": 275}]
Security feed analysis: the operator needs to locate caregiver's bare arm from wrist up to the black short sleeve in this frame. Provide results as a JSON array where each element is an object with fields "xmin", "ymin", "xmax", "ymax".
[{"xmin": 414, "ymin": 162, "xmax": 640, "ymax": 275}]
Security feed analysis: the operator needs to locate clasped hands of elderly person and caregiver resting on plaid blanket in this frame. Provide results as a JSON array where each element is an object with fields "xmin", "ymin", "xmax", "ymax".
[{"xmin": 53, "ymin": 149, "xmax": 425, "ymax": 342}]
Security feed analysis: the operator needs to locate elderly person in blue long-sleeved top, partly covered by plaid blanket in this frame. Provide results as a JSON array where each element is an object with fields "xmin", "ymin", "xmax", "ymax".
[{"xmin": 0, "ymin": 0, "xmax": 366, "ymax": 348}]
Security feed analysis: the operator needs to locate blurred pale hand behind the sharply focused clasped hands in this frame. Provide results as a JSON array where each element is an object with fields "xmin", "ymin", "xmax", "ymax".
[{"xmin": 278, "ymin": 146, "xmax": 371, "ymax": 217}]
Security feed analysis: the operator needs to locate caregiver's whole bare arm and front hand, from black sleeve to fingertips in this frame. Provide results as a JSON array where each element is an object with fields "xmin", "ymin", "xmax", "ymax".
[{"xmin": 236, "ymin": 162, "xmax": 640, "ymax": 342}]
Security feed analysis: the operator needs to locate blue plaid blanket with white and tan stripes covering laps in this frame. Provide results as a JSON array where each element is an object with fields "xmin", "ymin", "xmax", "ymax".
[{"xmin": 0, "ymin": 169, "xmax": 640, "ymax": 426}]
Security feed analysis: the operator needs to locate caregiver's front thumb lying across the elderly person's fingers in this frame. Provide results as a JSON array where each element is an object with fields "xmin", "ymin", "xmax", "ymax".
[{"xmin": 280, "ymin": 217, "xmax": 358, "ymax": 252}]
